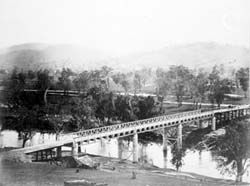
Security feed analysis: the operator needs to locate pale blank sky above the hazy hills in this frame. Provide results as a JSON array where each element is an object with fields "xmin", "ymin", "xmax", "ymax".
[{"xmin": 0, "ymin": 0, "xmax": 250, "ymax": 55}]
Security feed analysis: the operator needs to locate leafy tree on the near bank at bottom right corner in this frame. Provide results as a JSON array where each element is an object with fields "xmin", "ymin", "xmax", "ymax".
[{"xmin": 209, "ymin": 120, "xmax": 250, "ymax": 182}]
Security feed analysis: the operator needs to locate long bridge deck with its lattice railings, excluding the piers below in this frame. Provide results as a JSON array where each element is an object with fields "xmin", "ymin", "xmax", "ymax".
[{"xmin": 14, "ymin": 105, "xmax": 250, "ymax": 154}]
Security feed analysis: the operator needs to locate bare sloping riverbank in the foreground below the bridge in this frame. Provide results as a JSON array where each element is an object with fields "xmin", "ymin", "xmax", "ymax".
[{"xmin": 0, "ymin": 151, "xmax": 249, "ymax": 186}]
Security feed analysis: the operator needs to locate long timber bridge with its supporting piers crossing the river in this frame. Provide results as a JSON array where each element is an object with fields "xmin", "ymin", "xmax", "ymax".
[{"xmin": 14, "ymin": 105, "xmax": 250, "ymax": 162}]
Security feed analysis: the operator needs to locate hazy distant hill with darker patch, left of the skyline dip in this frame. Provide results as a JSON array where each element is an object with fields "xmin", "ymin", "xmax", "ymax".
[{"xmin": 0, "ymin": 43, "xmax": 108, "ymax": 71}]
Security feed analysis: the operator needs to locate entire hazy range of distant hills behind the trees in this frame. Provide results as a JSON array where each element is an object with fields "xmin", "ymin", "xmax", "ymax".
[{"xmin": 0, "ymin": 42, "xmax": 250, "ymax": 71}]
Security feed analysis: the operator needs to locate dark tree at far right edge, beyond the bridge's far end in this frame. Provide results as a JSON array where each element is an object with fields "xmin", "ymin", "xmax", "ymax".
[{"xmin": 236, "ymin": 68, "xmax": 249, "ymax": 97}]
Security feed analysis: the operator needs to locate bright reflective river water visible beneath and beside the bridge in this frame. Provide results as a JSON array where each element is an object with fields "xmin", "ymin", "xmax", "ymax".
[{"xmin": 0, "ymin": 130, "xmax": 250, "ymax": 182}]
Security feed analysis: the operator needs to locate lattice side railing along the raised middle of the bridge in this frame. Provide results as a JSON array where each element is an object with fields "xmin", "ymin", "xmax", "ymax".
[{"xmin": 62, "ymin": 110, "xmax": 201, "ymax": 138}]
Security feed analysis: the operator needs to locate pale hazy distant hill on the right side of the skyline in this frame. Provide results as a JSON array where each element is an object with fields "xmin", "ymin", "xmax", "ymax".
[{"xmin": 119, "ymin": 42, "xmax": 250, "ymax": 68}]
